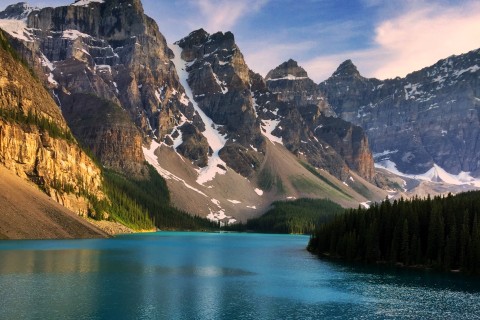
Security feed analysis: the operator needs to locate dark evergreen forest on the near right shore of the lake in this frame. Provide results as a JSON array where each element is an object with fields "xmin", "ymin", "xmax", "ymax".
[{"xmin": 308, "ymin": 191, "xmax": 480, "ymax": 274}]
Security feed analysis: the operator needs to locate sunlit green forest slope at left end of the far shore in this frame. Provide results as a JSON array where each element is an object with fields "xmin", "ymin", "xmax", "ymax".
[{"xmin": 102, "ymin": 165, "xmax": 219, "ymax": 230}]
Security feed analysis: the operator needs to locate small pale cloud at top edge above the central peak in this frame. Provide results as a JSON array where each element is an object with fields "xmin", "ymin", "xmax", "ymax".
[{"xmin": 194, "ymin": 0, "xmax": 269, "ymax": 32}]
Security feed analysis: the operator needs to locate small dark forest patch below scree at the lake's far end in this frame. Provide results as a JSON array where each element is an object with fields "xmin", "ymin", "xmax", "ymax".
[{"xmin": 226, "ymin": 199, "xmax": 345, "ymax": 234}]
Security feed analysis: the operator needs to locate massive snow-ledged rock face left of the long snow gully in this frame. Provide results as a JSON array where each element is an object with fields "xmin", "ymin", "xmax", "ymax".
[{"xmin": 0, "ymin": 0, "xmax": 193, "ymax": 176}]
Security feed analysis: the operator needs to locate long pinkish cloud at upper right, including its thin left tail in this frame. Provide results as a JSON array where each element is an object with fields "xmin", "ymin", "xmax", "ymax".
[{"xmin": 304, "ymin": 1, "xmax": 480, "ymax": 81}]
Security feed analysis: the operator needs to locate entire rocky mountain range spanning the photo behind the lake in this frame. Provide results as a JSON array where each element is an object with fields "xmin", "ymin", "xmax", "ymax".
[{"xmin": 0, "ymin": 0, "xmax": 480, "ymax": 232}]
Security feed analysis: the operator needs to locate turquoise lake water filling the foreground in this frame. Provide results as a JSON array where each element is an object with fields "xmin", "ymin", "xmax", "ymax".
[{"xmin": 0, "ymin": 232, "xmax": 480, "ymax": 320}]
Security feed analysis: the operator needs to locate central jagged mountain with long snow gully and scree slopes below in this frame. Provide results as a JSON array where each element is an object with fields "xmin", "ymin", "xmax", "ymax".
[{"xmin": 162, "ymin": 29, "xmax": 384, "ymax": 220}]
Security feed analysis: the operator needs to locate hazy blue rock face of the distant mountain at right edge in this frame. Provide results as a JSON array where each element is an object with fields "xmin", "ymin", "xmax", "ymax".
[{"xmin": 319, "ymin": 49, "xmax": 480, "ymax": 177}]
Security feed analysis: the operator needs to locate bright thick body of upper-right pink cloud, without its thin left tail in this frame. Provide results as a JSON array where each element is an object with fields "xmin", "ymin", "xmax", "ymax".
[{"xmin": 373, "ymin": 2, "xmax": 480, "ymax": 78}]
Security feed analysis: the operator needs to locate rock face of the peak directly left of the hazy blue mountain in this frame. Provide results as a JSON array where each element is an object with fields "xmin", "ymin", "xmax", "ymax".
[{"xmin": 258, "ymin": 60, "xmax": 375, "ymax": 180}]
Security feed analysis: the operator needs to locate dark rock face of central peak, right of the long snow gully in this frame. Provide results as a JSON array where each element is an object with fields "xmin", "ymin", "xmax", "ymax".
[{"xmin": 176, "ymin": 29, "xmax": 265, "ymax": 177}]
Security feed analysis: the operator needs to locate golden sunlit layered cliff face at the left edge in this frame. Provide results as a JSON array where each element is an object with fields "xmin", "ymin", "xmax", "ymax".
[{"xmin": 0, "ymin": 32, "xmax": 104, "ymax": 214}]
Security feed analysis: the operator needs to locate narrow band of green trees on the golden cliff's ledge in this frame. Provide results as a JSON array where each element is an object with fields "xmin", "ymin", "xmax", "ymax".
[{"xmin": 0, "ymin": 106, "xmax": 75, "ymax": 142}]
